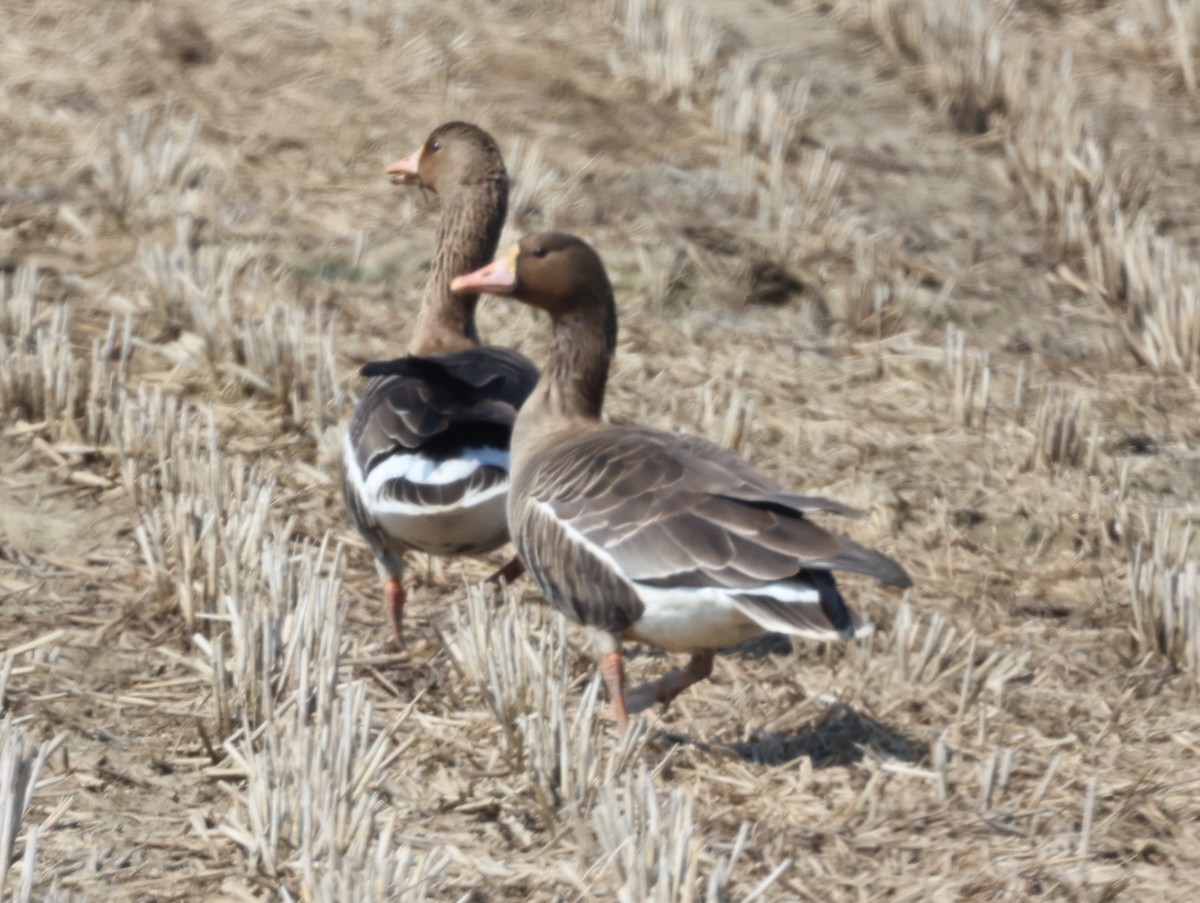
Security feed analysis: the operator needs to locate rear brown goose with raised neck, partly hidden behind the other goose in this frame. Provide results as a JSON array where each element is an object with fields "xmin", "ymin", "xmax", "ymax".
[{"xmin": 342, "ymin": 122, "xmax": 538, "ymax": 644}]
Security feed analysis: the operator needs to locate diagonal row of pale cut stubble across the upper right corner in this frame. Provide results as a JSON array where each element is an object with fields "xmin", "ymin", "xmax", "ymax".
[{"xmin": 842, "ymin": 0, "xmax": 1200, "ymax": 376}]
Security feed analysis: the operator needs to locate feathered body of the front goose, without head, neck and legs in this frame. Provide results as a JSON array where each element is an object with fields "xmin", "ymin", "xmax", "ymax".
[{"xmin": 510, "ymin": 426, "xmax": 911, "ymax": 645}]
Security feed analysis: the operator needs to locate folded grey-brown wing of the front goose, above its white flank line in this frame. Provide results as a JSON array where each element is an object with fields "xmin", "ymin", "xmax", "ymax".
[{"xmin": 527, "ymin": 426, "xmax": 911, "ymax": 595}]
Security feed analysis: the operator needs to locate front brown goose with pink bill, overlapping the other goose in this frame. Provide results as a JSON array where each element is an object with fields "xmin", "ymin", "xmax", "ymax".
[{"xmin": 451, "ymin": 233, "xmax": 911, "ymax": 729}]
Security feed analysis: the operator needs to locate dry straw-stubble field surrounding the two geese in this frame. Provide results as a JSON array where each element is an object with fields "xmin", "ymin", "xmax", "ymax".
[{"xmin": 0, "ymin": 0, "xmax": 1200, "ymax": 902}]
